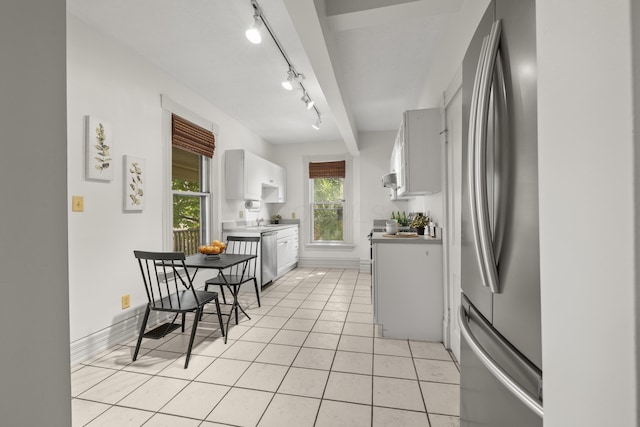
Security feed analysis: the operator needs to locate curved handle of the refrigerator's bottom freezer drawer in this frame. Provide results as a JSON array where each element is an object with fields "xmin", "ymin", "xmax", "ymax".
[{"xmin": 458, "ymin": 305, "xmax": 544, "ymax": 418}]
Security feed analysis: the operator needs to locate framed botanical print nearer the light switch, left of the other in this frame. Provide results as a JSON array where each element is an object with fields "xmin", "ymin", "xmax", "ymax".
[{"xmin": 85, "ymin": 116, "xmax": 113, "ymax": 181}]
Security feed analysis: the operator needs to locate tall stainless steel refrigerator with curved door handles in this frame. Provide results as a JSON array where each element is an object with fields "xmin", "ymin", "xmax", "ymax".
[{"xmin": 459, "ymin": 0, "xmax": 543, "ymax": 427}]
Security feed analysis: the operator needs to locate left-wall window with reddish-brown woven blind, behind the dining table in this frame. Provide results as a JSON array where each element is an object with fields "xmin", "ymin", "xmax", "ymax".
[{"xmin": 171, "ymin": 115, "xmax": 215, "ymax": 255}]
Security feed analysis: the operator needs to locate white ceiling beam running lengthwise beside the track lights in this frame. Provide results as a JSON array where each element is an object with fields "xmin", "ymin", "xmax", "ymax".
[{"xmin": 284, "ymin": 0, "xmax": 360, "ymax": 157}]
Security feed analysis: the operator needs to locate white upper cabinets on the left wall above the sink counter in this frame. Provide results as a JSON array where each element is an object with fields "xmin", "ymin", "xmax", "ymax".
[{"xmin": 224, "ymin": 150, "xmax": 286, "ymax": 203}]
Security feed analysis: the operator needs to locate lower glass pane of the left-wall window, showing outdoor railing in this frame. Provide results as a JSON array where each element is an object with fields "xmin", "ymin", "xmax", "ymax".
[{"xmin": 173, "ymin": 195, "xmax": 202, "ymax": 255}]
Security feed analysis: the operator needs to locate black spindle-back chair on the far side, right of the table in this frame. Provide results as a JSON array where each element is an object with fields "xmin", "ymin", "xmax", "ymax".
[{"xmin": 204, "ymin": 236, "xmax": 261, "ymax": 324}]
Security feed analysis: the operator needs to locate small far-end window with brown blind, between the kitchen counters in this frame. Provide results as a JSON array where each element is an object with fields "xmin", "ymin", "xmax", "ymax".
[{"xmin": 308, "ymin": 160, "xmax": 349, "ymax": 243}]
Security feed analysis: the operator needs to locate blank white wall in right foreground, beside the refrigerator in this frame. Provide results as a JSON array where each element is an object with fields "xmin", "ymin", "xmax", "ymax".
[{"xmin": 536, "ymin": 0, "xmax": 640, "ymax": 427}]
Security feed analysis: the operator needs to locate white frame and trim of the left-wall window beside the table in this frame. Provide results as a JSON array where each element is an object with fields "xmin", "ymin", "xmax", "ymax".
[{"xmin": 160, "ymin": 94, "xmax": 219, "ymax": 251}]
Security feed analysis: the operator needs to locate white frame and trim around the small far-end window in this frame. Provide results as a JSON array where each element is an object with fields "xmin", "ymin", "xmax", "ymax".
[{"xmin": 302, "ymin": 153, "xmax": 354, "ymax": 250}]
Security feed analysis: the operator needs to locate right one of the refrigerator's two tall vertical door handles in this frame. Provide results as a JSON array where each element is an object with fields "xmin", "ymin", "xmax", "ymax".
[{"xmin": 473, "ymin": 20, "xmax": 504, "ymax": 294}]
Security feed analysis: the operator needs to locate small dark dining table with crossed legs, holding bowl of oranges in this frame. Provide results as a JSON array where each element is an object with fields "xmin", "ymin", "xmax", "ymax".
[{"xmin": 184, "ymin": 253, "xmax": 257, "ymax": 344}]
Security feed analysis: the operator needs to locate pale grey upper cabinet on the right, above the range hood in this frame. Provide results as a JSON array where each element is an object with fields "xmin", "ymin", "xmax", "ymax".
[{"xmin": 390, "ymin": 108, "xmax": 442, "ymax": 198}]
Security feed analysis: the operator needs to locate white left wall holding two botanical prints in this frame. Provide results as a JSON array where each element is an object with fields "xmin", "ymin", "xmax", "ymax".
[{"xmin": 67, "ymin": 16, "xmax": 270, "ymax": 361}]
